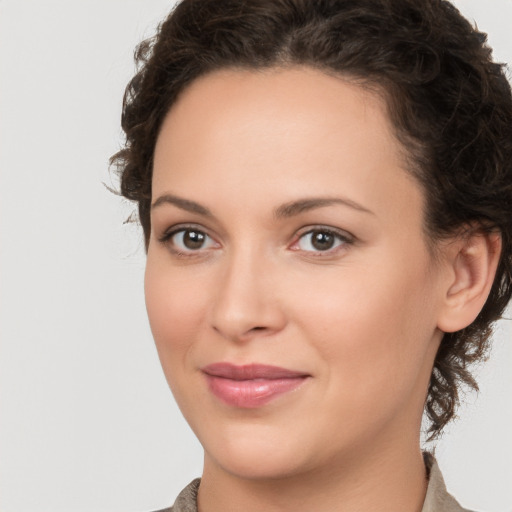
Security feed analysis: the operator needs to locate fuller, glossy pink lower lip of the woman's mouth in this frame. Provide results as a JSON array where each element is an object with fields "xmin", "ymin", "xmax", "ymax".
[{"xmin": 206, "ymin": 375, "xmax": 307, "ymax": 409}]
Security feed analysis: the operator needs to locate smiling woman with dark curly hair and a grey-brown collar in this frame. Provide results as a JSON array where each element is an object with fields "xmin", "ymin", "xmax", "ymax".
[{"xmin": 113, "ymin": 0, "xmax": 512, "ymax": 512}]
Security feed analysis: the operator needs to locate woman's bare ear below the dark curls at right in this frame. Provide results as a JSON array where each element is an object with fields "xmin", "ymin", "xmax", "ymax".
[{"xmin": 437, "ymin": 229, "xmax": 501, "ymax": 332}]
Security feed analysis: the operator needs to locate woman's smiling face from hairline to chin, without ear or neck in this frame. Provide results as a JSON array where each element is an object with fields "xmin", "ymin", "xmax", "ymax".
[{"xmin": 145, "ymin": 68, "xmax": 443, "ymax": 478}]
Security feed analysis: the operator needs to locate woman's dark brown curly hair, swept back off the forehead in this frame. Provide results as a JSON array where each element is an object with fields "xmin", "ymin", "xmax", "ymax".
[{"xmin": 111, "ymin": 0, "xmax": 512, "ymax": 439}]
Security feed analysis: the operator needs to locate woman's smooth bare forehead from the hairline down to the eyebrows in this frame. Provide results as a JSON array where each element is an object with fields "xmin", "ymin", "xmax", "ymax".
[{"xmin": 153, "ymin": 67, "xmax": 419, "ymax": 222}]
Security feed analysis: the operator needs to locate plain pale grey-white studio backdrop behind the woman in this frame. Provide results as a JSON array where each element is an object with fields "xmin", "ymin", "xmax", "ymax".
[{"xmin": 0, "ymin": 0, "xmax": 512, "ymax": 512}]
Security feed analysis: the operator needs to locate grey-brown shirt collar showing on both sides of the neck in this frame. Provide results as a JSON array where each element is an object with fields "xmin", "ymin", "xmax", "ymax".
[{"xmin": 157, "ymin": 452, "xmax": 470, "ymax": 512}]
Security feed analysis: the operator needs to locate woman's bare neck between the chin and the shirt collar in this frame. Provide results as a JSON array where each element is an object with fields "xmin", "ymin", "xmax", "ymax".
[{"xmin": 198, "ymin": 439, "xmax": 427, "ymax": 512}]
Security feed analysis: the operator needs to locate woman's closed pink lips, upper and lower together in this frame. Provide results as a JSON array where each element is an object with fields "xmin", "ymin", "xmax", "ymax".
[{"xmin": 202, "ymin": 363, "xmax": 309, "ymax": 409}]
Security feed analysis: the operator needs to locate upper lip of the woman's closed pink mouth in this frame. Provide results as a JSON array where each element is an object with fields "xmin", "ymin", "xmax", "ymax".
[{"xmin": 201, "ymin": 363, "xmax": 309, "ymax": 380}]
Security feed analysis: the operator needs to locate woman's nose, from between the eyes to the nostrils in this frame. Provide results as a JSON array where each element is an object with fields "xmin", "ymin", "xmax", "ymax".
[{"xmin": 211, "ymin": 246, "xmax": 286, "ymax": 342}]
